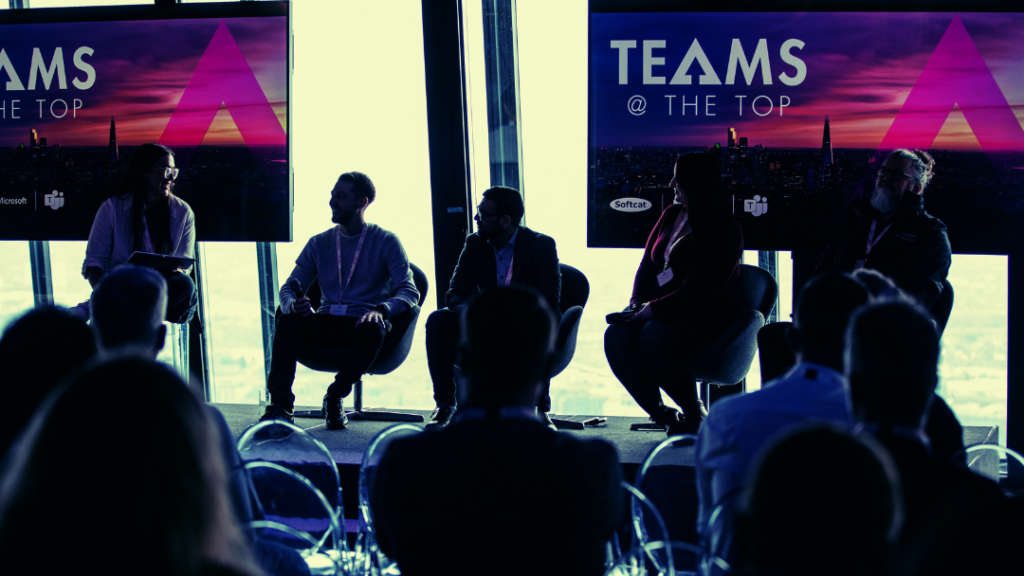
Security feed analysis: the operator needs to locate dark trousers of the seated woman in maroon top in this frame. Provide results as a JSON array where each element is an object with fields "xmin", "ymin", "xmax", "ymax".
[{"xmin": 604, "ymin": 320, "xmax": 697, "ymax": 415}]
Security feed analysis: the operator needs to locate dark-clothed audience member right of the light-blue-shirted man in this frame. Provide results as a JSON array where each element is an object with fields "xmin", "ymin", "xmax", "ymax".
[{"xmin": 845, "ymin": 300, "xmax": 1005, "ymax": 574}]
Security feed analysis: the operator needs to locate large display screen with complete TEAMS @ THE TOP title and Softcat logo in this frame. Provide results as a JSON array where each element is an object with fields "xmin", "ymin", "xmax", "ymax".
[{"xmin": 587, "ymin": 6, "xmax": 1024, "ymax": 253}]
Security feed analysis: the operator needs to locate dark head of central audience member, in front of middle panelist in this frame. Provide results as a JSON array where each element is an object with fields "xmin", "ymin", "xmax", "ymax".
[{"xmin": 459, "ymin": 287, "xmax": 555, "ymax": 407}]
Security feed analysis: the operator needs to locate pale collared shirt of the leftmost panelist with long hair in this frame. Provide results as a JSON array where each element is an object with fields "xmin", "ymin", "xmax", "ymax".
[{"xmin": 82, "ymin": 196, "xmax": 196, "ymax": 276}]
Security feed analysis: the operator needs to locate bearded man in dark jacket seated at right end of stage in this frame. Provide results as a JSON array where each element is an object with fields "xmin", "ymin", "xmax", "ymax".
[{"xmin": 815, "ymin": 150, "xmax": 952, "ymax": 308}]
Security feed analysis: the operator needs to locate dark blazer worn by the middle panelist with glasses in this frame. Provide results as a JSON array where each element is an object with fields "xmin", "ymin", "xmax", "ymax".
[{"xmin": 444, "ymin": 227, "xmax": 562, "ymax": 318}]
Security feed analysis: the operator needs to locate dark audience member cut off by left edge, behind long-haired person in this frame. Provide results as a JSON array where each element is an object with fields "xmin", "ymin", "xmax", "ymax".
[{"xmin": 0, "ymin": 306, "xmax": 96, "ymax": 460}]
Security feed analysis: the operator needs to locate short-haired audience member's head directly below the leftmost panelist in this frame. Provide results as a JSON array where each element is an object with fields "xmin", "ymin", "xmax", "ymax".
[{"xmin": 89, "ymin": 265, "xmax": 167, "ymax": 358}]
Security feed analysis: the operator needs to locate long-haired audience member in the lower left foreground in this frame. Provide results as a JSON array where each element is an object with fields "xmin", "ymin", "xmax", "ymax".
[{"xmin": 0, "ymin": 358, "xmax": 260, "ymax": 576}]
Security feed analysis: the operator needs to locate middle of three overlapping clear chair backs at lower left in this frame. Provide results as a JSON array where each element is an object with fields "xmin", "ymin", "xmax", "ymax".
[{"xmin": 245, "ymin": 460, "xmax": 350, "ymax": 574}]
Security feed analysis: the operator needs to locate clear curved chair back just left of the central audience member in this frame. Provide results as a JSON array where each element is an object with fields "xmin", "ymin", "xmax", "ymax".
[{"xmin": 355, "ymin": 424, "xmax": 421, "ymax": 574}]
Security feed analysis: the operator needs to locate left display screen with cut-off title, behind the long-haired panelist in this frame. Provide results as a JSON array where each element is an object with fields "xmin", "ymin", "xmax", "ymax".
[{"xmin": 0, "ymin": 2, "xmax": 292, "ymax": 242}]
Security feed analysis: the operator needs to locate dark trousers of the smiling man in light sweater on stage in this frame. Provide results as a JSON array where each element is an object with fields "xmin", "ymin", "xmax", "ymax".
[{"xmin": 266, "ymin": 314, "xmax": 387, "ymax": 409}]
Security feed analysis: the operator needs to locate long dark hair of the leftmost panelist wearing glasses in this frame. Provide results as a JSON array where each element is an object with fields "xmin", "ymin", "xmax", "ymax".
[{"xmin": 114, "ymin": 143, "xmax": 174, "ymax": 254}]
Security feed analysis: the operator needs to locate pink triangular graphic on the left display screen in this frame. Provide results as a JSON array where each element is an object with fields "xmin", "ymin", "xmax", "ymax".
[{"xmin": 160, "ymin": 20, "xmax": 287, "ymax": 147}]
